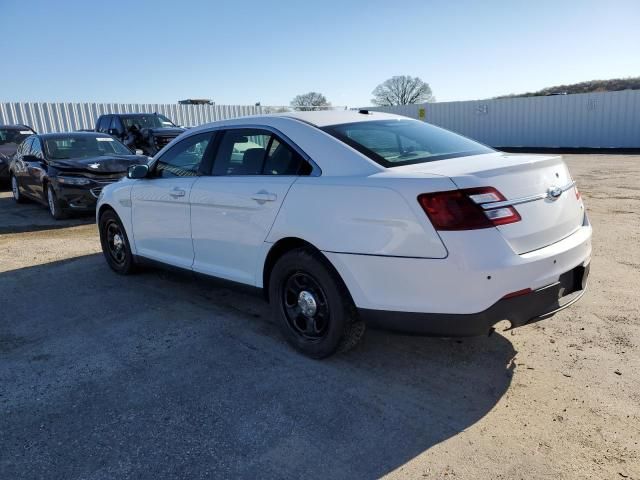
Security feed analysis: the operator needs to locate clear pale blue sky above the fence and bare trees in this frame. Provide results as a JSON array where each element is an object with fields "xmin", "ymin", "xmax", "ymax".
[{"xmin": 0, "ymin": 0, "xmax": 640, "ymax": 106}]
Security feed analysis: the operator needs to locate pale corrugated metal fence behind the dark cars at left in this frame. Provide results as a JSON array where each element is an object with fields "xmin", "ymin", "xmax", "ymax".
[{"xmin": 0, "ymin": 102, "xmax": 262, "ymax": 133}]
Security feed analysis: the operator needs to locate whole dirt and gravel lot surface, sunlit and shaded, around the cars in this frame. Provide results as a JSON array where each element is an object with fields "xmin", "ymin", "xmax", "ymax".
[{"xmin": 0, "ymin": 155, "xmax": 640, "ymax": 479}]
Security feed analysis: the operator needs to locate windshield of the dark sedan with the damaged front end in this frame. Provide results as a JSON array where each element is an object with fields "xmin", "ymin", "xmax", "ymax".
[{"xmin": 44, "ymin": 135, "xmax": 132, "ymax": 160}]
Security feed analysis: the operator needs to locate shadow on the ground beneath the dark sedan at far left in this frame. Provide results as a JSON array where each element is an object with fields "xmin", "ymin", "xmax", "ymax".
[{"xmin": 0, "ymin": 188, "xmax": 96, "ymax": 235}]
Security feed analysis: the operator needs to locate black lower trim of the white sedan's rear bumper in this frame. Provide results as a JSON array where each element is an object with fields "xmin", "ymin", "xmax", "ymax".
[{"xmin": 358, "ymin": 264, "xmax": 589, "ymax": 337}]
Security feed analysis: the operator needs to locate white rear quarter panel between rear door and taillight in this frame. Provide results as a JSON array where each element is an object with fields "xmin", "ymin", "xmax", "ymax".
[{"xmin": 267, "ymin": 176, "xmax": 452, "ymax": 258}]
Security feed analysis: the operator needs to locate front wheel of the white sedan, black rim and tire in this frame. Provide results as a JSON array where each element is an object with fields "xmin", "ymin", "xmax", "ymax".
[{"xmin": 98, "ymin": 210, "xmax": 136, "ymax": 275}]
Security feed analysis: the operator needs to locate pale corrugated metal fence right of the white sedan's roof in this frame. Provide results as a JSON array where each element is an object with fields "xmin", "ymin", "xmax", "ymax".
[{"xmin": 370, "ymin": 90, "xmax": 640, "ymax": 148}]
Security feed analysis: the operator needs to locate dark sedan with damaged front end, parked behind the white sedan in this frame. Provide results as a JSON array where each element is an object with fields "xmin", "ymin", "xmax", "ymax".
[{"xmin": 9, "ymin": 132, "xmax": 149, "ymax": 219}]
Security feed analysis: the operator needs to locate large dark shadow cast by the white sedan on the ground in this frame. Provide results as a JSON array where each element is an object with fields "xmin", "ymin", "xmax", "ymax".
[{"xmin": 0, "ymin": 255, "xmax": 515, "ymax": 478}]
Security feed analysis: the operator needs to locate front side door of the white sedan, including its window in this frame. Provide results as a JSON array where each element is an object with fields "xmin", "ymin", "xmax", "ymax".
[{"xmin": 131, "ymin": 132, "xmax": 214, "ymax": 268}]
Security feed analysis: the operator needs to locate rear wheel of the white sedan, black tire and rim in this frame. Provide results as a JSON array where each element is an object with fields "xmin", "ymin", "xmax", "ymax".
[{"xmin": 269, "ymin": 248, "xmax": 365, "ymax": 359}]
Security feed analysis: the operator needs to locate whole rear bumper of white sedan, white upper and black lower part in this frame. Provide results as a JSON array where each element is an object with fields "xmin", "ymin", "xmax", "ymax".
[{"xmin": 324, "ymin": 220, "xmax": 591, "ymax": 335}]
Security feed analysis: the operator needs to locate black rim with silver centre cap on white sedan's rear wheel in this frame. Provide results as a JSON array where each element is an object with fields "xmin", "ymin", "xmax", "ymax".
[{"xmin": 282, "ymin": 272, "xmax": 329, "ymax": 341}]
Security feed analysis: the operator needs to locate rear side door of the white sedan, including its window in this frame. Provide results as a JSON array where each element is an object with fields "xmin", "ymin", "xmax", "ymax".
[{"xmin": 191, "ymin": 129, "xmax": 312, "ymax": 285}]
